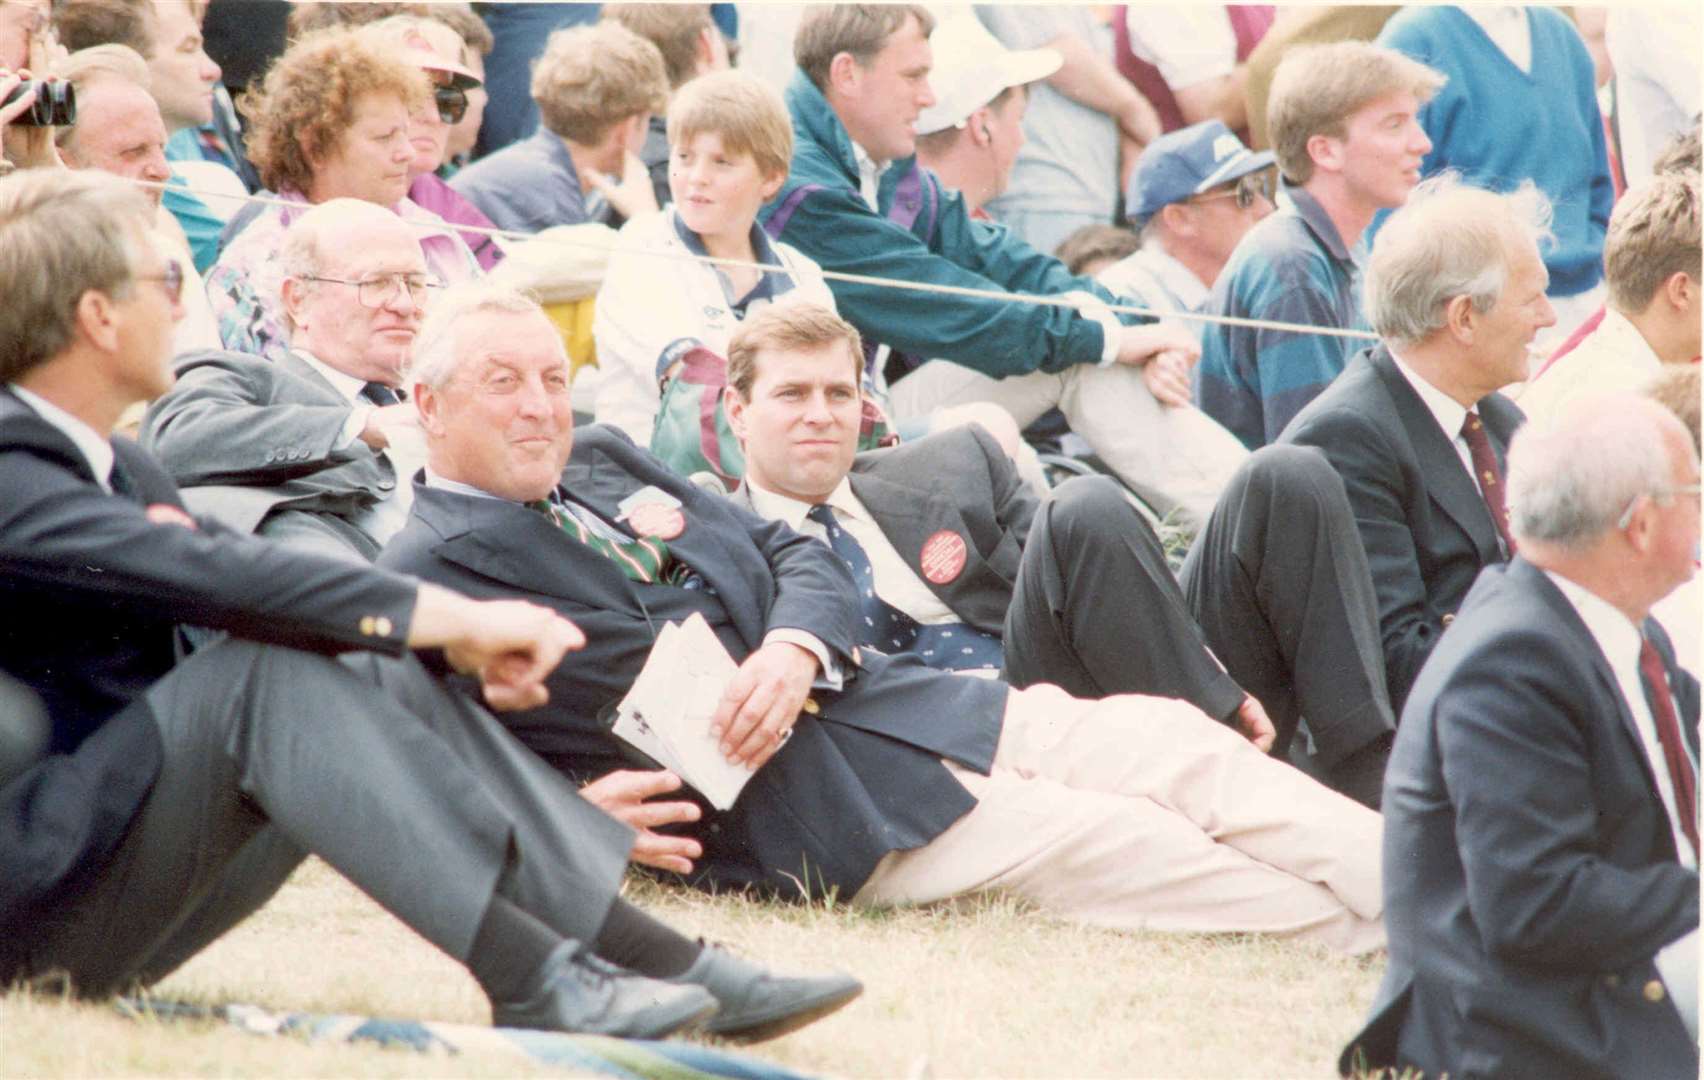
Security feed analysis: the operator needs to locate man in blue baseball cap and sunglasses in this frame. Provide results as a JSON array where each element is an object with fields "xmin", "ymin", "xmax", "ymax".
[{"xmin": 1097, "ymin": 119, "xmax": 1273, "ymax": 337}]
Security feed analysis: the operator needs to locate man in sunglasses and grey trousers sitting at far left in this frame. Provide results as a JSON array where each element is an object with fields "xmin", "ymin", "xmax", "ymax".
[{"xmin": 0, "ymin": 170, "xmax": 855, "ymax": 1036}]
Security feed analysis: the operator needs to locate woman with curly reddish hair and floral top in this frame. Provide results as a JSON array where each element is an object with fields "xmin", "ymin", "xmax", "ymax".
[{"xmin": 208, "ymin": 29, "xmax": 481, "ymax": 359}]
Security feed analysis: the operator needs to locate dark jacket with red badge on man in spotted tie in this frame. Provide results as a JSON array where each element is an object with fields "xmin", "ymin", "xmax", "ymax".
[{"xmin": 734, "ymin": 424, "xmax": 1041, "ymax": 637}]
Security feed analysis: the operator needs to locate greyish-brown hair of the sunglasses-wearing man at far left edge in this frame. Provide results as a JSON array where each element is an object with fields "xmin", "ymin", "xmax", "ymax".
[{"xmin": 0, "ymin": 169, "xmax": 153, "ymax": 383}]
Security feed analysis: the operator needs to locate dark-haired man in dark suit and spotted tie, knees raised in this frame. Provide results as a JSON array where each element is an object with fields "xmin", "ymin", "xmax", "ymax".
[{"xmin": 724, "ymin": 306, "xmax": 1394, "ymax": 804}]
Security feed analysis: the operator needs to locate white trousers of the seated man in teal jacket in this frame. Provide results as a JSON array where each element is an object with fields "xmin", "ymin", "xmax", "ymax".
[{"xmin": 891, "ymin": 359, "xmax": 1249, "ymax": 528}]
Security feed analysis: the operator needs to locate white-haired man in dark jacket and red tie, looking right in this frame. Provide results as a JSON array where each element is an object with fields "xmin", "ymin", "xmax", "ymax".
[{"xmin": 1280, "ymin": 175, "xmax": 1556, "ymax": 714}]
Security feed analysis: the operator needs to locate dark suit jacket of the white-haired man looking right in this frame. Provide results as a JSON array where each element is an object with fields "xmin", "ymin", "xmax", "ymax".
[{"xmin": 1278, "ymin": 344, "xmax": 1525, "ymax": 712}]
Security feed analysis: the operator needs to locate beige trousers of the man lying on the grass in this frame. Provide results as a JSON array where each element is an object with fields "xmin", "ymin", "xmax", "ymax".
[{"xmin": 855, "ymin": 685, "xmax": 1385, "ymax": 952}]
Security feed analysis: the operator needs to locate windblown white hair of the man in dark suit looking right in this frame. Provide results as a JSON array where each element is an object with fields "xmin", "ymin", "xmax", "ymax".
[{"xmin": 1361, "ymin": 172, "xmax": 1551, "ymax": 346}]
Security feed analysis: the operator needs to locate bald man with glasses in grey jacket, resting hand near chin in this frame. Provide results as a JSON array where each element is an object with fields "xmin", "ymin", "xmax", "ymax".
[{"xmin": 141, "ymin": 199, "xmax": 438, "ymax": 560}]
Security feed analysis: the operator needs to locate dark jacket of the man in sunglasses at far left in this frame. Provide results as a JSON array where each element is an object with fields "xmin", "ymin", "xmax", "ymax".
[{"xmin": 0, "ymin": 387, "xmax": 416, "ymax": 940}]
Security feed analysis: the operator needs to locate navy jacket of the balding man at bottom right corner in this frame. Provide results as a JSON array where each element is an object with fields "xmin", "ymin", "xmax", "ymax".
[{"xmin": 1343, "ymin": 559, "xmax": 1699, "ymax": 1080}]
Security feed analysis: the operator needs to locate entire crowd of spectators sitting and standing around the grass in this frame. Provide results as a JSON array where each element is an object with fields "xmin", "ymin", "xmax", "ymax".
[{"xmin": 0, "ymin": 0, "xmax": 1704, "ymax": 1077}]
